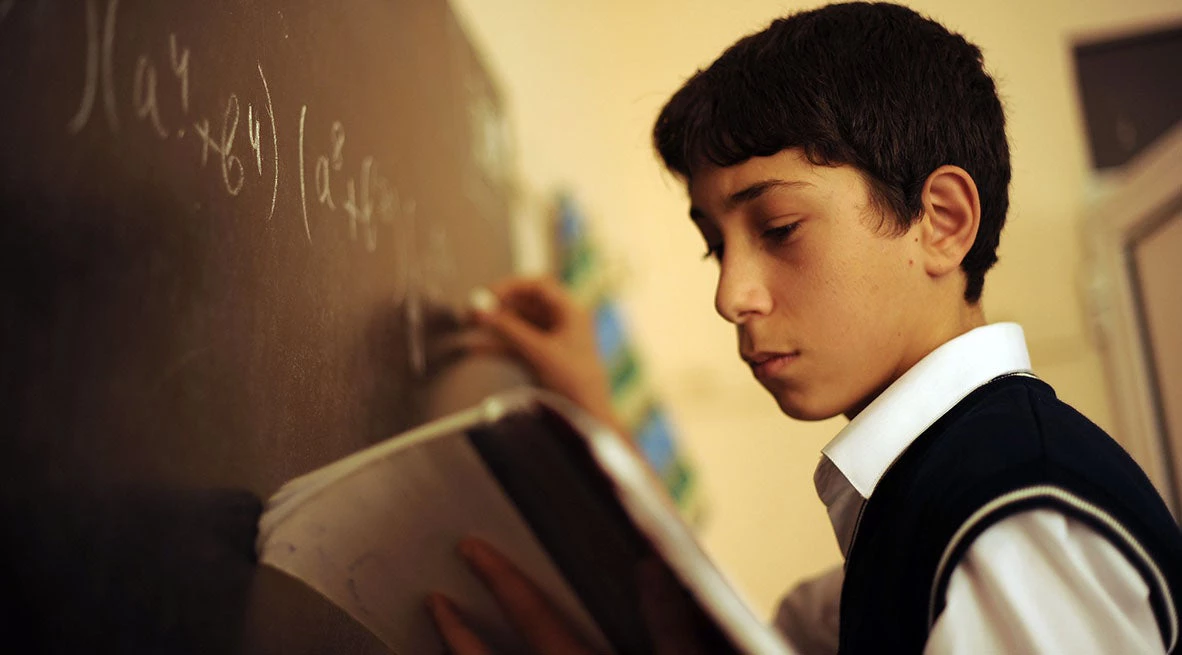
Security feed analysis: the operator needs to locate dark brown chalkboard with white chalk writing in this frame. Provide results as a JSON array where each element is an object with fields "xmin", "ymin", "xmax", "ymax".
[{"xmin": 0, "ymin": 0, "xmax": 520, "ymax": 653}]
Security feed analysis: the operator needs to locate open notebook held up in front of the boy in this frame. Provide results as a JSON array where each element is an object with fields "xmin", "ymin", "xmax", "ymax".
[{"xmin": 258, "ymin": 389, "xmax": 791, "ymax": 655}]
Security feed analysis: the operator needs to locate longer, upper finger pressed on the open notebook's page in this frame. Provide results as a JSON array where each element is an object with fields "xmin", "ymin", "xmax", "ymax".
[{"xmin": 460, "ymin": 538, "xmax": 591, "ymax": 655}]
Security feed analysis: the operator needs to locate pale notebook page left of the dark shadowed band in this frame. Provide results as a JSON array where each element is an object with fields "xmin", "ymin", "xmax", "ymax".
[{"xmin": 259, "ymin": 399, "xmax": 611, "ymax": 655}]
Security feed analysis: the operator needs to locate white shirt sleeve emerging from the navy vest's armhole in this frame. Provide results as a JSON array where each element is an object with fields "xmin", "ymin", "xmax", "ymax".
[{"xmin": 924, "ymin": 510, "xmax": 1165, "ymax": 655}]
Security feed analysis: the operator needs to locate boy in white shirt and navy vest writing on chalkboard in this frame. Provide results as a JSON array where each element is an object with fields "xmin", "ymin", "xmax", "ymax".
[{"xmin": 433, "ymin": 4, "xmax": 1182, "ymax": 653}]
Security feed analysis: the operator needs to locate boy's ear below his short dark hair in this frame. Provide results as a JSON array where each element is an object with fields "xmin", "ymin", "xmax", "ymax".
[{"xmin": 920, "ymin": 166, "xmax": 981, "ymax": 277}]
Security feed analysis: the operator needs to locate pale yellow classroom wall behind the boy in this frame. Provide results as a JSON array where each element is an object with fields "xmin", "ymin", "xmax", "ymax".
[{"xmin": 453, "ymin": 0, "xmax": 1182, "ymax": 614}]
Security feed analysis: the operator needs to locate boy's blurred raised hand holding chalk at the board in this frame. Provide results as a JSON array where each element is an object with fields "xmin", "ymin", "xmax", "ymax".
[{"xmin": 474, "ymin": 277, "xmax": 621, "ymax": 430}]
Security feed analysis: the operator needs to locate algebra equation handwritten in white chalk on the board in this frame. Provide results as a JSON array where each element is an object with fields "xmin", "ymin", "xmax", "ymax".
[{"xmin": 65, "ymin": 0, "xmax": 415, "ymax": 254}]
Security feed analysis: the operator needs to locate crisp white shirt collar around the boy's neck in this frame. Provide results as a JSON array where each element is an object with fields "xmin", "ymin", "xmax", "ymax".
[{"xmin": 817, "ymin": 323, "xmax": 1031, "ymax": 500}]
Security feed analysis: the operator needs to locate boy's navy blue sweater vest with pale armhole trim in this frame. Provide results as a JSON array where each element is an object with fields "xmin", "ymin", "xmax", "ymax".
[{"xmin": 840, "ymin": 376, "xmax": 1182, "ymax": 654}]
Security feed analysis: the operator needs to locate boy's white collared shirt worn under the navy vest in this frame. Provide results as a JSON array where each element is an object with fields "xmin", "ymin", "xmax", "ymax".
[{"xmin": 775, "ymin": 323, "xmax": 1164, "ymax": 655}]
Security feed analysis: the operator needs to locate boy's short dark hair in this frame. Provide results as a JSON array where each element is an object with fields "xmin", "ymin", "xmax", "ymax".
[{"xmin": 652, "ymin": 2, "xmax": 1009, "ymax": 303}]
